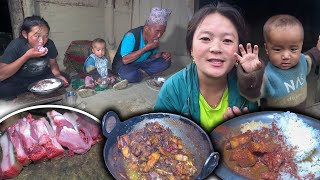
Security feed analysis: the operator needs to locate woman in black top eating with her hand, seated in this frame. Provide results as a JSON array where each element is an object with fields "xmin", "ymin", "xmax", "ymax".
[{"xmin": 0, "ymin": 16, "xmax": 69, "ymax": 99}]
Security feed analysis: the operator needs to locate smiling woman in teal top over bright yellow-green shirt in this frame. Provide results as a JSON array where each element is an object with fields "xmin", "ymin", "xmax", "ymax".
[{"xmin": 154, "ymin": 3, "xmax": 257, "ymax": 133}]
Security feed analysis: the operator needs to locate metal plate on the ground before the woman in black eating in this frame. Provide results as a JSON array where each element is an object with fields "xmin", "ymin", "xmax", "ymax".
[{"xmin": 28, "ymin": 78, "xmax": 64, "ymax": 95}]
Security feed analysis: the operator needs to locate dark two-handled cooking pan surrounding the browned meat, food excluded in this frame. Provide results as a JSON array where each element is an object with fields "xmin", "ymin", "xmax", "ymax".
[{"xmin": 102, "ymin": 111, "xmax": 219, "ymax": 180}]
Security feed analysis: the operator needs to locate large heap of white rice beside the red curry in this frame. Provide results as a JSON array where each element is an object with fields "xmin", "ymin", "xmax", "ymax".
[{"xmin": 274, "ymin": 112, "xmax": 320, "ymax": 179}]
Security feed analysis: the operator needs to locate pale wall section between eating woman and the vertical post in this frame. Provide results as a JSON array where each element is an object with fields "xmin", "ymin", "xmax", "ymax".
[{"xmin": 36, "ymin": 0, "xmax": 106, "ymax": 70}]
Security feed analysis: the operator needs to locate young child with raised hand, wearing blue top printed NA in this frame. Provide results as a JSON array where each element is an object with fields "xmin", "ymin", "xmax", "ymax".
[{"xmin": 236, "ymin": 15, "xmax": 320, "ymax": 112}]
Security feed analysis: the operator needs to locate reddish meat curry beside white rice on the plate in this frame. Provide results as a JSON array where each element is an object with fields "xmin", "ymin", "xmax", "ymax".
[{"xmin": 223, "ymin": 128, "xmax": 297, "ymax": 179}]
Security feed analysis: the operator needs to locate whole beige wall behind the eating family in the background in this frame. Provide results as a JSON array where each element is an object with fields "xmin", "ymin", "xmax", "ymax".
[{"xmin": 16, "ymin": 0, "xmax": 194, "ymax": 70}]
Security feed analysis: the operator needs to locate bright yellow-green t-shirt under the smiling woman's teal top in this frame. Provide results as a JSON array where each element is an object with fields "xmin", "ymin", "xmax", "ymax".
[{"xmin": 199, "ymin": 88, "xmax": 229, "ymax": 133}]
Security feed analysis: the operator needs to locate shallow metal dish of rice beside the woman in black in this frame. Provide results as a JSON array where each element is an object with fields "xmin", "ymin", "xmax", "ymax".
[{"xmin": 28, "ymin": 78, "xmax": 64, "ymax": 95}]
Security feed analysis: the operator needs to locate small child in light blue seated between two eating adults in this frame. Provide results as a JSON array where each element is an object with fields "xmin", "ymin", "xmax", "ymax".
[{"xmin": 84, "ymin": 38, "xmax": 110, "ymax": 79}]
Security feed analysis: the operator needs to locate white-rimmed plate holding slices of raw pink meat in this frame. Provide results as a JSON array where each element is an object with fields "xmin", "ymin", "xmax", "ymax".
[{"xmin": 0, "ymin": 105, "xmax": 108, "ymax": 179}]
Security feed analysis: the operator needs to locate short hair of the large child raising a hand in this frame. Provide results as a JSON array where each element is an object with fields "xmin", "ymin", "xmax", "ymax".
[{"xmin": 263, "ymin": 14, "xmax": 304, "ymax": 41}]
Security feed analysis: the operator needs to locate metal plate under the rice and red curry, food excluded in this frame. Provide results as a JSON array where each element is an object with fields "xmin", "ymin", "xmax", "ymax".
[{"xmin": 210, "ymin": 111, "xmax": 320, "ymax": 180}]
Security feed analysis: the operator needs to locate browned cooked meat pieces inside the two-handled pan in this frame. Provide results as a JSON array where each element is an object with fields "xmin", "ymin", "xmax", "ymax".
[{"xmin": 117, "ymin": 122, "xmax": 197, "ymax": 180}]
